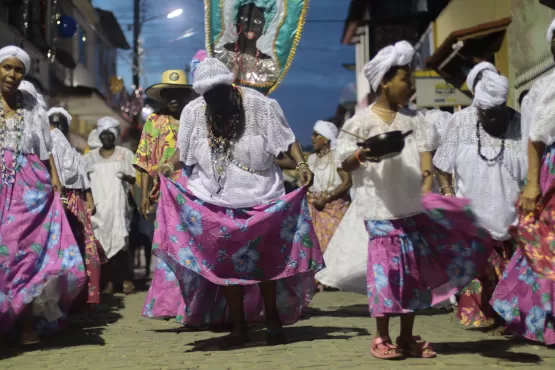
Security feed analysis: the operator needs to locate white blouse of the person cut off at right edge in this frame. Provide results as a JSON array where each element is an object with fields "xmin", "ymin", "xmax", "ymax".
[{"xmin": 522, "ymin": 73, "xmax": 555, "ymax": 145}]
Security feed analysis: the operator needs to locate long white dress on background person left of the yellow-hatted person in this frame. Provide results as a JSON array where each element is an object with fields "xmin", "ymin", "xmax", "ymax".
[{"xmin": 85, "ymin": 146, "xmax": 135, "ymax": 258}]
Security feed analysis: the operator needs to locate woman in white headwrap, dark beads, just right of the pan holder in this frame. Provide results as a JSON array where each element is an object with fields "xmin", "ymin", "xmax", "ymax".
[{"xmin": 434, "ymin": 62, "xmax": 527, "ymax": 327}]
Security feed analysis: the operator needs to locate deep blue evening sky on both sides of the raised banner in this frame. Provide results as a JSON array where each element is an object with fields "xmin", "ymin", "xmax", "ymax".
[{"xmin": 93, "ymin": 0, "xmax": 355, "ymax": 144}]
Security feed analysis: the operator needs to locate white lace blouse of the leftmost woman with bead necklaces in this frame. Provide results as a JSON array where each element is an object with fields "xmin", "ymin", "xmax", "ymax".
[{"xmin": 4, "ymin": 92, "xmax": 52, "ymax": 161}]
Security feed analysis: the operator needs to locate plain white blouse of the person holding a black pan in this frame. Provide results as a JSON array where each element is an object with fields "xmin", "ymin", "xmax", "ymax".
[{"xmin": 337, "ymin": 106, "xmax": 439, "ymax": 220}]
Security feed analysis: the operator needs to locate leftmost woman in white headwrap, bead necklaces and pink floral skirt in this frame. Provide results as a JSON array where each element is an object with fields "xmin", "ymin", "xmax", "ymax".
[{"xmin": 0, "ymin": 46, "xmax": 86, "ymax": 343}]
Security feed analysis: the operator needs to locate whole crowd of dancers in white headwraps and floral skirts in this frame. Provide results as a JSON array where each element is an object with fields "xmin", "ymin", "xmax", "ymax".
[{"xmin": 0, "ymin": 17, "xmax": 555, "ymax": 359}]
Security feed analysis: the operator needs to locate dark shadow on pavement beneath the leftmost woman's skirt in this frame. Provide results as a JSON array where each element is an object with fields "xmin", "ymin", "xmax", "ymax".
[{"xmin": 0, "ymin": 296, "xmax": 124, "ymax": 360}]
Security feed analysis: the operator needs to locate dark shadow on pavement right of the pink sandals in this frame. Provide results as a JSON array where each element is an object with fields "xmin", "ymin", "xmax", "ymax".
[{"xmin": 433, "ymin": 339, "xmax": 542, "ymax": 364}]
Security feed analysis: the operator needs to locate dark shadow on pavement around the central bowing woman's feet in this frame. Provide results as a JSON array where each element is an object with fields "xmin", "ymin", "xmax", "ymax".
[{"xmin": 186, "ymin": 326, "xmax": 370, "ymax": 352}]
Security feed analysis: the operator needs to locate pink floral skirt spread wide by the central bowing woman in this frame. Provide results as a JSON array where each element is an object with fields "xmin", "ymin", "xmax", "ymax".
[{"xmin": 143, "ymin": 178, "xmax": 323, "ymax": 326}]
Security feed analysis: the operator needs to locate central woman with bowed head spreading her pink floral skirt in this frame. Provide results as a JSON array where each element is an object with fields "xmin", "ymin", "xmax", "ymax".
[{"xmin": 150, "ymin": 58, "xmax": 323, "ymax": 345}]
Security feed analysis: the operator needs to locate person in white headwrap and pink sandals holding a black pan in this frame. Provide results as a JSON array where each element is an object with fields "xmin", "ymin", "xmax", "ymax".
[{"xmin": 337, "ymin": 41, "xmax": 489, "ymax": 359}]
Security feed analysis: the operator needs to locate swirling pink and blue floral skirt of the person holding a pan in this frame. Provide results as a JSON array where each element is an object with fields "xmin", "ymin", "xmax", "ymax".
[{"xmin": 366, "ymin": 194, "xmax": 493, "ymax": 317}]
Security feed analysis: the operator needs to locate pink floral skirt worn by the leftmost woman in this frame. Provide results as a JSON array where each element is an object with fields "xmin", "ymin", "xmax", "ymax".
[{"xmin": 0, "ymin": 151, "xmax": 86, "ymax": 332}]
